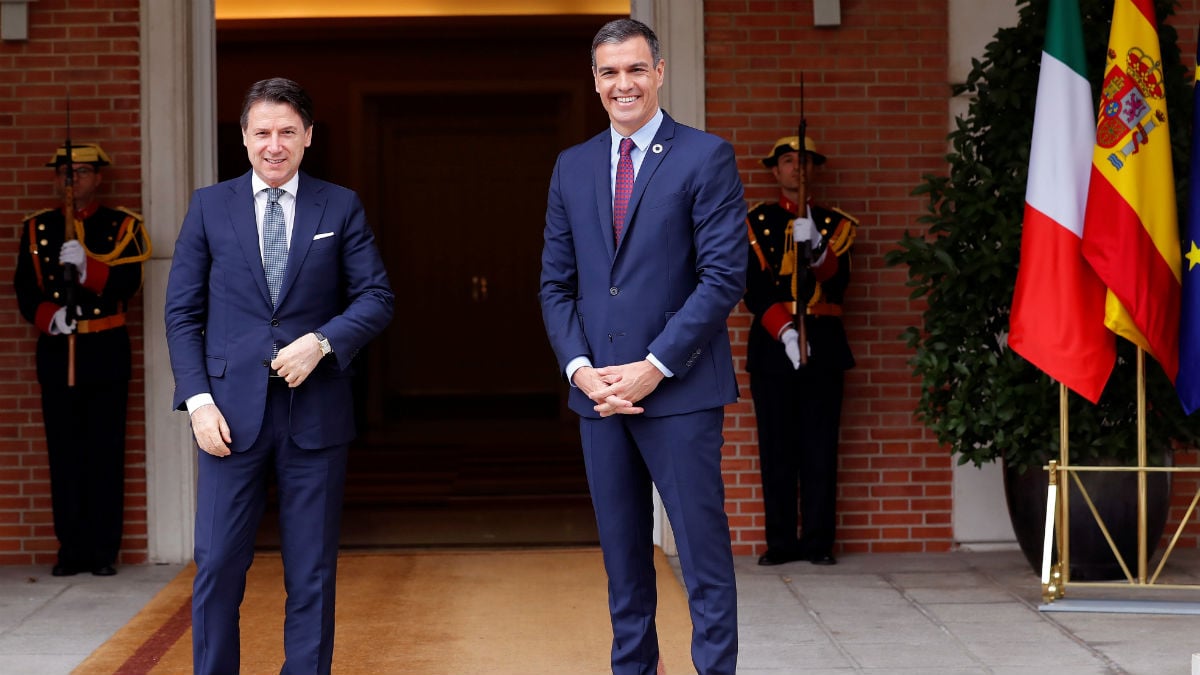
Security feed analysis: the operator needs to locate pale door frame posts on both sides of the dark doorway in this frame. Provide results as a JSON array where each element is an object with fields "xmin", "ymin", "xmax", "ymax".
[{"xmin": 139, "ymin": 0, "xmax": 704, "ymax": 563}]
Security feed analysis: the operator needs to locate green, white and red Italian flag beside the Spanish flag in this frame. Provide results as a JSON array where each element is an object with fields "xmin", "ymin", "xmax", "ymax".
[{"xmin": 1008, "ymin": 0, "xmax": 1120, "ymax": 404}]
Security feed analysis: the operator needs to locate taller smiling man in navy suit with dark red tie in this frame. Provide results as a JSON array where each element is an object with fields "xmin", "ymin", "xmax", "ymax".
[{"xmin": 539, "ymin": 19, "xmax": 746, "ymax": 675}]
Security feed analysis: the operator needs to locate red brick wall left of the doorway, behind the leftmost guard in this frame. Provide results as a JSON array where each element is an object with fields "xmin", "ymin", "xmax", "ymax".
[{"xmin": 0, "ymin": 0, "xmax": 146, "ymax": 565}]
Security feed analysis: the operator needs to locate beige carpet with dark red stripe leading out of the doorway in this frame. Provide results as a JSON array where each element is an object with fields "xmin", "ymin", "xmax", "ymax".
[{"xmin": 74, "ymin": 548, "xmax": 695, "ymax": 675}]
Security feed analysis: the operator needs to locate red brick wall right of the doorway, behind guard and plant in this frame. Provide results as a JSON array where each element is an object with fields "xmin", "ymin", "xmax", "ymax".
[{"xmin": 705, "ymin": 0, "xmax": 1198, "ymax": 555}]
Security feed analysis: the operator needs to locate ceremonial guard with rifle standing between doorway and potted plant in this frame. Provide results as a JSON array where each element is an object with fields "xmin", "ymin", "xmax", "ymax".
[{"xmin": 745, "ymin": 136, "xmax": 857, "ymax": 565}]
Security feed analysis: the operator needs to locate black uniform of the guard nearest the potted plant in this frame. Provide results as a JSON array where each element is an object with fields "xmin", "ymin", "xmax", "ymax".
[{"xmin": 745, "ymin": 199, "xmax": 857, "ymax": 560}]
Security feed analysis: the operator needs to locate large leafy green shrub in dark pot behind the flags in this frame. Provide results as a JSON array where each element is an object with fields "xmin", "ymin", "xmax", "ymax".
[{"xmin": 887, "ymin": 0, "xmax": 1198, "ymax": 578}]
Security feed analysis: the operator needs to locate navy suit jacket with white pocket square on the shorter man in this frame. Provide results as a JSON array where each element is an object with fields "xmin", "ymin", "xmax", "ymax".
[{"xmin": 166, "ymin": 172, "xmax": 392, "ymax": 452}]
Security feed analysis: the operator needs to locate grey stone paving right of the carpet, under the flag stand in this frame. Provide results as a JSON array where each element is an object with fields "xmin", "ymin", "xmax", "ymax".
[{"xmin": 720, "ymin": 551, "xmax": 1200, "ymax": 675}]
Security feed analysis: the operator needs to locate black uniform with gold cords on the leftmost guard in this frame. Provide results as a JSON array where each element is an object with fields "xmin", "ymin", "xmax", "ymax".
[{"xmin": 13, "ymin": 205, "xmax": 150, "ymax": 573}]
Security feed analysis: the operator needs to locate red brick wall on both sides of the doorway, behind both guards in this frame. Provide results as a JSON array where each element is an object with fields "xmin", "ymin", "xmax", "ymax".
[{"xmin": 0, "ymin": 0, "xmax": 1200, "ymax": 565}]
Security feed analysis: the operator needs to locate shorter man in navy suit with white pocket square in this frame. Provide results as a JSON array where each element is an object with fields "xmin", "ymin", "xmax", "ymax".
[{"xmin": 166, "ymin": 78, "xmax": 392, "ymax": 675}]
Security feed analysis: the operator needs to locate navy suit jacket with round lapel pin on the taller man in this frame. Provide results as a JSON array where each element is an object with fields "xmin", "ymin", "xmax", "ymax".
[{"xmin": 539, "ymin": 114, "xmax": 746, "ymax": 417}]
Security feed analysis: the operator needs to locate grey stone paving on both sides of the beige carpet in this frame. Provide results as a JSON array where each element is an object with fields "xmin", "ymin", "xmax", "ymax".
[{"xmin": 0, "ymin": 550, "xmax": 1200, "ymax": 675}]
